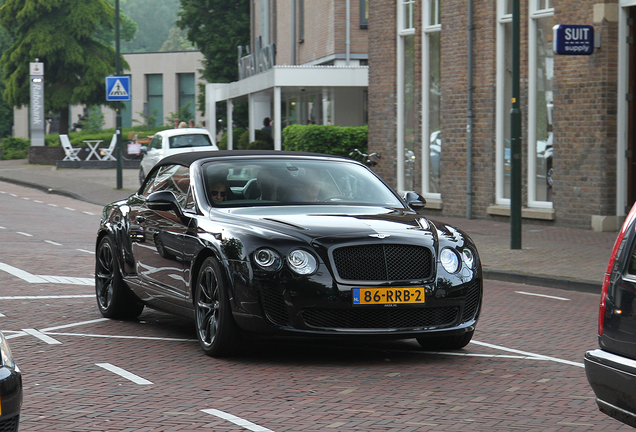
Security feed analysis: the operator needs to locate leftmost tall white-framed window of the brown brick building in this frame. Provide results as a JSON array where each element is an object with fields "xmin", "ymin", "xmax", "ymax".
[{"xmin": 397, "ymin": 0, "xmax": 417, "ymax": 191}]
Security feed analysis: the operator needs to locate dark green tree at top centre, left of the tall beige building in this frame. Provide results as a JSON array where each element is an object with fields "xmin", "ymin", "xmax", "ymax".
[{"xmin": 177, "ymin": 0, "xmax": 250, "ymax": 82}]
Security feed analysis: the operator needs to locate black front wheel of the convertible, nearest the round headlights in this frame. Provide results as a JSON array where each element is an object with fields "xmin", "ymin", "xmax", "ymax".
[{"xmin": 194, "ymin": 257, "xmax": 241, "ymax": 357}]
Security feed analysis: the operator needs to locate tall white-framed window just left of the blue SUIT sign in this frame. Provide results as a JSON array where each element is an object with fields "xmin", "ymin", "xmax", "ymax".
[{"xmin": 528, "ymin": 0, "xmax": 554, "ymax": 208}]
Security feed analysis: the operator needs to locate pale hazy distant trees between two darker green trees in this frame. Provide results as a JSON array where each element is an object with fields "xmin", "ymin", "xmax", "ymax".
[{"xmin": 119, "ymin": 0, "xmax": 179, "ymax": 52}]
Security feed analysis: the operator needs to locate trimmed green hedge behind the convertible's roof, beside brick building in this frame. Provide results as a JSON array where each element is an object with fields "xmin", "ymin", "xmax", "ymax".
[{"xmin": 283, "ymin": 125, "xmax": 369, "ymax": 157}]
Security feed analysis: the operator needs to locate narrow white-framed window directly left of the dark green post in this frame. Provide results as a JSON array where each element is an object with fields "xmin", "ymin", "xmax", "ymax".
[{"xmin": 495, "ymin": 0, "xmax": 512, "ymax": 206}]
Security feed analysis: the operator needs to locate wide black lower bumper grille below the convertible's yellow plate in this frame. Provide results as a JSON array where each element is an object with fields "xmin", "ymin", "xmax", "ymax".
[{"xmin": 302, "ymin": 307, "xmax": 458, "ymax": 330}]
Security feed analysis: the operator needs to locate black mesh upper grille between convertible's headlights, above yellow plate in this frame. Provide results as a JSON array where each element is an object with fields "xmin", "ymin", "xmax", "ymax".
[{"xmin": 333, "ymin": 244, "xmax": 433, "ymax": 281}]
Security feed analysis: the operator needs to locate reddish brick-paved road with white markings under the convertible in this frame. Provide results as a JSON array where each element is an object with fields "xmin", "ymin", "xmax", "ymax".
[{"xmin": 0, "ymin": 184, "xmax": 631, "ymax": 432}]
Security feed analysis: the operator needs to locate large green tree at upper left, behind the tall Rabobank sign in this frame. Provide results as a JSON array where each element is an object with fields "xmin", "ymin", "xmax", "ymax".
[{"xmin": 0, "ymin": 0, "xmax": 128, "ymax": 133}]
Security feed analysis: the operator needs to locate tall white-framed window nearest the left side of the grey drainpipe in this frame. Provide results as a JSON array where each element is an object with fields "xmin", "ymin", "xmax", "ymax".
[{"xmin": 422, "ymin": 0, "xmax": 442, "ymax": 199}]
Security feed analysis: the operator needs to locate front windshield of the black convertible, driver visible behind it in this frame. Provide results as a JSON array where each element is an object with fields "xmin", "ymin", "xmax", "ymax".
[{"xmin": 202, "ymin": 159, "xmax": 402, "ymax": 207}]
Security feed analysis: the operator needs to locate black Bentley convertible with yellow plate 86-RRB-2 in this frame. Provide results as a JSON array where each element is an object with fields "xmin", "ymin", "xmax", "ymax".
[{"xmin": 95, "ymin": 151, "xmax": 483, "ymax": 356}]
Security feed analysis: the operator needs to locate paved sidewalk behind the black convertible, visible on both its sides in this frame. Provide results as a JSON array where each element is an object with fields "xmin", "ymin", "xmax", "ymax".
[{"xmin": 0, "ymin": 160, "xmax": 616, "ymax": 293}]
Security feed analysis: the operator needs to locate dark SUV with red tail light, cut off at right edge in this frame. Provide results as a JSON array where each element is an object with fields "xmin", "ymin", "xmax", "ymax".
[{"xmin": 585, "ymin": 205, "xmax": 636, "ymax": 427}]
